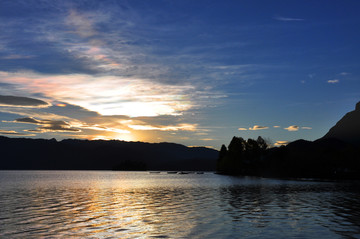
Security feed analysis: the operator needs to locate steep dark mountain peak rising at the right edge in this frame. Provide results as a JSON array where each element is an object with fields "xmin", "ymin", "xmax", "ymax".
[{"xmin": 322, "ymin": 102, "xmax": 360, "ymax": 144}]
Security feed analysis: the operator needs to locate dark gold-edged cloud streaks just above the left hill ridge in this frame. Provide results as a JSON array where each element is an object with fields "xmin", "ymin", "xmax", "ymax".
[{"xmin": 14, "ymin": 117, "xmax": 81, "ymax": 133}]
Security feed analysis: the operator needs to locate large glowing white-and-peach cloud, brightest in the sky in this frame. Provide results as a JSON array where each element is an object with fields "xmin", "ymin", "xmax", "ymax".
[{"xmin": 0, "ymin": 72, "xmax": 198, "ymax": 117}]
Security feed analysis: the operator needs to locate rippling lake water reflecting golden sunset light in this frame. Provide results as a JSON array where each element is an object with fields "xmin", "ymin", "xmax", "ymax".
[{"xmin": 0, "ymin": 171, "xmax": 360, "ymax": 238}]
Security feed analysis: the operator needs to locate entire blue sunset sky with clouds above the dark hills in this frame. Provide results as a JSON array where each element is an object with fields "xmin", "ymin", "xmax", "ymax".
[{"xmin": 0, "ymin": 0, "xmax": 360, "ymax": 149}]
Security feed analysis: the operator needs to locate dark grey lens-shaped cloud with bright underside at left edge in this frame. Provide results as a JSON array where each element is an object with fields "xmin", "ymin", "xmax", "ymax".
[{"xmin": 0, "ymin": 95, "xmax": 50, "ymax": 108}]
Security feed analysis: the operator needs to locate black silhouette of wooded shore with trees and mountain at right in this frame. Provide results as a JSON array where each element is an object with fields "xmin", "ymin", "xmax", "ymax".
[{"xmin": 217, "ymin": 102, "xmax": 360, "ymax": 179}]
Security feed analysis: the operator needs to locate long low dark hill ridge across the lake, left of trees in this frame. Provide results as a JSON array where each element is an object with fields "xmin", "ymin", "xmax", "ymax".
[{"xmin": 0, "ymin": 136, "xmax": 218, "ymax": 171}]
